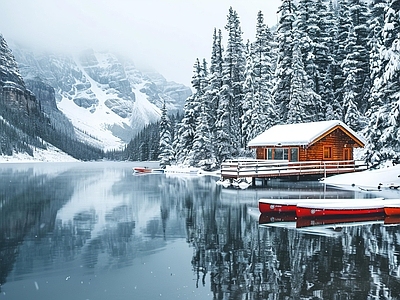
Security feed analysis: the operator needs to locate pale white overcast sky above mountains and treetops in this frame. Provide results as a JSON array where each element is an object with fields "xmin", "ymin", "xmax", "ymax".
[{"xmin": 0, "ymin": 0, "xmax": 281, "ymax": 85}]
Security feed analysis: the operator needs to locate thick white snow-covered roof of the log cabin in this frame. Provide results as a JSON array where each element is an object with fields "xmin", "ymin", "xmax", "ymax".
[{"xmin": 248, "ymin": 120, "xmax": 366, "ymax": 147}]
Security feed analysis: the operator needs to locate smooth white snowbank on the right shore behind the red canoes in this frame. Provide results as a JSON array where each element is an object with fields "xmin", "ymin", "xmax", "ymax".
[{"xmin": 323, "ymin": 165, "xmax": 400, "ymax": 189}]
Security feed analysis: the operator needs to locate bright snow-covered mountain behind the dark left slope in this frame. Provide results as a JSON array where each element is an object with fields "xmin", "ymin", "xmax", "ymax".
[{"xmin": 10, "ymin": 43, "xmax": 191, "ymax": 150}]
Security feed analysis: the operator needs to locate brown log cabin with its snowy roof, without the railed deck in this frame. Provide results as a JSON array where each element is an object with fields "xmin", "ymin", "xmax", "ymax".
[{"xmin": 248, "ymin": 120, "xmax": 365, "ymax": 162}]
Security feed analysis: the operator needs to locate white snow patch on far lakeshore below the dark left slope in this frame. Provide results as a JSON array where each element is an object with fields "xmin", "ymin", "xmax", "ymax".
[{"xmin": 0, "ymin": 145, "xmax": 78, "ymax": 163}]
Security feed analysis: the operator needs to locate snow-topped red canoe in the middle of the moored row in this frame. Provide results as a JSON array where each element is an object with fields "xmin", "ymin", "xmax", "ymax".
[{"xmin": 296, "ymin": 198, "xmax": 384, "ymax": 218}]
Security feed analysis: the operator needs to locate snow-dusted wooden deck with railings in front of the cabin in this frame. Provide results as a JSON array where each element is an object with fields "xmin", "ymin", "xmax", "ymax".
[{"xmin": 221, "ymin": 159, "xmax": 367, "ymax": 183}]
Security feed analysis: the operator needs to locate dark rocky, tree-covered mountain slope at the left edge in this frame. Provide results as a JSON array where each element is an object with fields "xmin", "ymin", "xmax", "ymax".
[{"xmin": 0, "ymin": 34, "xmax": 104, "ymax": 160}]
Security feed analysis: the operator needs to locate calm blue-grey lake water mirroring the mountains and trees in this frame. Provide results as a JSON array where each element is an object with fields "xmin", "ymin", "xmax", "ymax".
[{"xmin": 0, "ymin": 163, "xmax": 400, "ymax": 300}]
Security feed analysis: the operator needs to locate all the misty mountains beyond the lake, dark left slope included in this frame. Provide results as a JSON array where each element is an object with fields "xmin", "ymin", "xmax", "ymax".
[{"xmin": 0, "ymin": 34, "xmax": 191, "ymax": 160}]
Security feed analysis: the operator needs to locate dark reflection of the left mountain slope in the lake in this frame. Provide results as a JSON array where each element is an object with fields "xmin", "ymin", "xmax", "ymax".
[{"xmin": 0, "ymin": 168, "xmax": 73, "ymax": 287}]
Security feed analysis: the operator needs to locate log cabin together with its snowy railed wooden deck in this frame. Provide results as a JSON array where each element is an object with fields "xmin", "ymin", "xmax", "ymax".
[{"xmin": 221, "ymin": 120, "xmax": 366, "ymax": 184}]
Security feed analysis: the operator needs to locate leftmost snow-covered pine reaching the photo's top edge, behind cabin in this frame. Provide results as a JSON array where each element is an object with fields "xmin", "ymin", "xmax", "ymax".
[{"xmin": 274, "ymin": 0, "xmax": 296, "ymax": 123}]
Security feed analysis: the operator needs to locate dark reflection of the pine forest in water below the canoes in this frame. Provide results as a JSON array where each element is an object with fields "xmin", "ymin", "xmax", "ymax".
[{"xmin": 187, "ymin": 191, "xmax": 400, "ymax": 299}]
